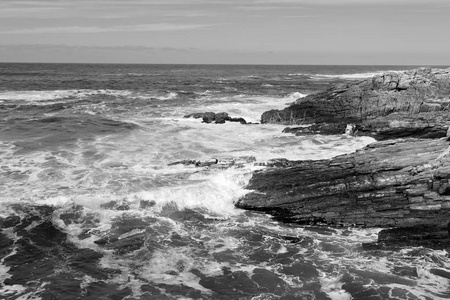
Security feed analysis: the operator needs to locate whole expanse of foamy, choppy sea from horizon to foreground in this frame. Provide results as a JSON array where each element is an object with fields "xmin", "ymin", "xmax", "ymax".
[{"xmin": 0, "ymin": 64, "xmax": 450, "ymax": 300}]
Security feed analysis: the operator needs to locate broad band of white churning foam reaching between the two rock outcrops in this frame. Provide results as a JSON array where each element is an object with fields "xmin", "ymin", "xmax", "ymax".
[{"xmin": 0, "ymin": 118, "xmax": 373, "ymax": 209}]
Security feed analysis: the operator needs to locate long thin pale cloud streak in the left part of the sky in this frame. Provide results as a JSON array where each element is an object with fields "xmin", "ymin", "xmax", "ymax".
[{"xmin": 0, "ymin": 23, "xmax": 213, "ymax": 34}]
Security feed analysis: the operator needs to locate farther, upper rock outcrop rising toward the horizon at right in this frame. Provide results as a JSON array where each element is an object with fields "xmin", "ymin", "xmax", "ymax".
[{"xmin": 261, "ymin": 68, "xmax": 450, "ymax": 140}]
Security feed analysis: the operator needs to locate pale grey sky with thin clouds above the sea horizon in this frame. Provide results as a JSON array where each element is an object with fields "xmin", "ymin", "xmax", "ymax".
[{"xmin": 0, "ymin": 0, "xmax": 450, "ymax": 65}]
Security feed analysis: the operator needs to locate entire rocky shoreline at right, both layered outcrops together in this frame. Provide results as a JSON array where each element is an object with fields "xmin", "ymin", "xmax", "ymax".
[{"xmin": 236, "ymin": 68, "xmax": 450, "ymax": 249}]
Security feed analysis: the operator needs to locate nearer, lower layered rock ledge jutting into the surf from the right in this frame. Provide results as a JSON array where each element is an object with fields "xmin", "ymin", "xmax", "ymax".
[{"xmin": 236, "ymin": 138, "xmax": 450, "ymax": 245}]
